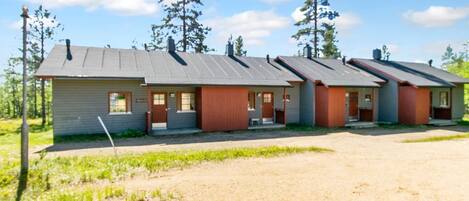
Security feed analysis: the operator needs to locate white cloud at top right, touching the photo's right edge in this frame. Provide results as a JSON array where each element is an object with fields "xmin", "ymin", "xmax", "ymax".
[{"xmin": 403, "ymin": 6, "xmax": 469, "ymax": 28}]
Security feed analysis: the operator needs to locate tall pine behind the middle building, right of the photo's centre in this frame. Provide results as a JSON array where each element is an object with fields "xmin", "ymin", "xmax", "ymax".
[{"xmin": 292, "ymin": 0, "xmax": 339, "ymax": 58}]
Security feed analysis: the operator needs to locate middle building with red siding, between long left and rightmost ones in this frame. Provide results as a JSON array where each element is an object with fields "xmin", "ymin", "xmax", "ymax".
[{"xmin": 277, "ymin": 46, "xmax": 385, "ymax": 127}]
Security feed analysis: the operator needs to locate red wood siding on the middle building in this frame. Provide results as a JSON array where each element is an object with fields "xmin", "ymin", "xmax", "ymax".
[{"xmin": 316, "ymin": 86, "xmax": 345, "ymax": 128}]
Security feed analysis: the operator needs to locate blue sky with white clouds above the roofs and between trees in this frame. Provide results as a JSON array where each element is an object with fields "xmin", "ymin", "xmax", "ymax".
[{"xmin": 0, "ymin": 0, "xmax": 469, "ymax": 80}]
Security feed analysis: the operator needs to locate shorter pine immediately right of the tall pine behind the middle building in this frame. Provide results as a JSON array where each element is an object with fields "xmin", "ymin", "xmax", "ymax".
[{"xmin": 321, "ymin": 23, "xmax": 341, "ymax": 59}]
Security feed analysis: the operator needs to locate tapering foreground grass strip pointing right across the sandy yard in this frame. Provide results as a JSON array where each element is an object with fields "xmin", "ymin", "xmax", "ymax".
[{"xmin": 0, "ymin": 146, "xmax": 332, "ymax": 200}]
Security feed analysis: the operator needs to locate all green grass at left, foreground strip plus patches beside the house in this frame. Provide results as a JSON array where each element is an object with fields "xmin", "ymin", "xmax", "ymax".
[{"xmin": 0, "ymin": 119, "xmax": 332, "ymax": 201}]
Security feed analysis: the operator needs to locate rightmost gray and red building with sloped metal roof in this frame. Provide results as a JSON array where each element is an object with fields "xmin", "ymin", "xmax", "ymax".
[{"xmin": 349, "ymin": 50, "xmax": 469, "ymax": 125}]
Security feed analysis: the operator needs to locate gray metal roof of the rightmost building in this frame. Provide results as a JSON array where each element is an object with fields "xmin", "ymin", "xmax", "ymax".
[{"xmin": 351, "ymin": 58, "xmax": 469, "ymax": 87}]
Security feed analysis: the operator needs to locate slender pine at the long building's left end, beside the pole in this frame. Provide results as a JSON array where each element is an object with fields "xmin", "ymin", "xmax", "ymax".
[{"xmin": 29, "ymin": 5, "xmax": 63, "ymax": 126}]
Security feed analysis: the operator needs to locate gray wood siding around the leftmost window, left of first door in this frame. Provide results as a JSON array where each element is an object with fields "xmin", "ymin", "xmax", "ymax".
[{"xmin": 52, "ymin": 79, "xmax": 147, "ymax": 135}]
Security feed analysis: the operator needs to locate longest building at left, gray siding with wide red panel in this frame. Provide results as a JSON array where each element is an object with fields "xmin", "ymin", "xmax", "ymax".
[{"xmin": 36, "ymin": 39, "xmax": 303, "ymax": 135}]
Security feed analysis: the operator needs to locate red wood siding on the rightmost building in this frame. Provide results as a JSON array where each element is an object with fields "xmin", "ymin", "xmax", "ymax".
[{"xmin": 399, "ymin": 86, "xmax": 430, "ymax": 125}]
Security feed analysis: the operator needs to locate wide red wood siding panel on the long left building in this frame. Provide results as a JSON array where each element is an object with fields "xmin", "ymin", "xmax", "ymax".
[{"xmin": 196, "ymin": 87, "xmax": 248, "ymax": 132}]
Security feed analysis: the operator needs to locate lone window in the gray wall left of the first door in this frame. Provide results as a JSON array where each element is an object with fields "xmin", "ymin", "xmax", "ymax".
[{"xmin": 109, "ymin": 92, "xmax": 132, "ymax": 114}]
